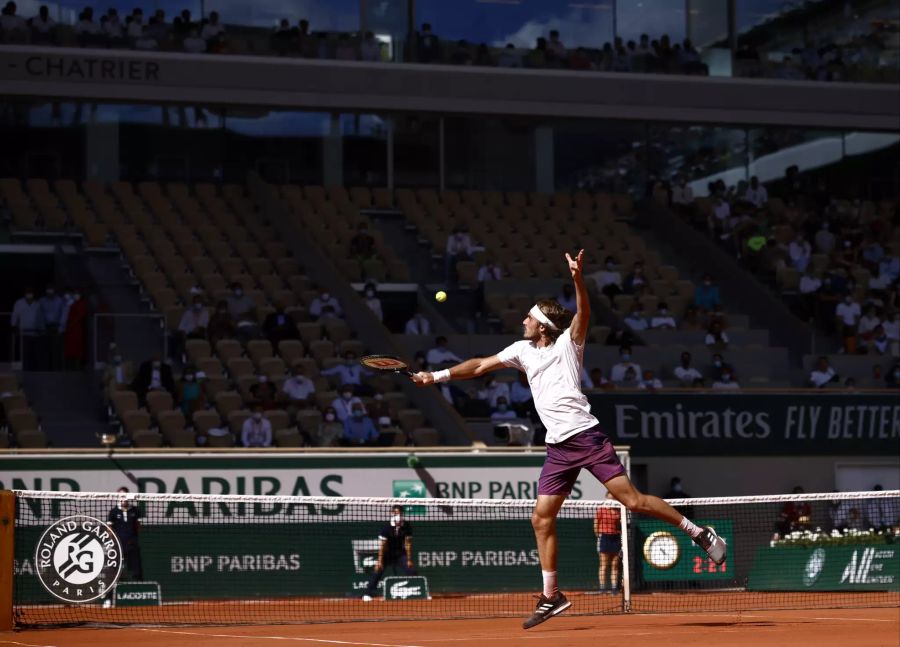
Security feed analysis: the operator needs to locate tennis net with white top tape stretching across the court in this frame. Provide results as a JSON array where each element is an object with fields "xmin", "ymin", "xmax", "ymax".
[{"xmin": 0, "ymin": 491, "xmax": 900, "ymax": 626}]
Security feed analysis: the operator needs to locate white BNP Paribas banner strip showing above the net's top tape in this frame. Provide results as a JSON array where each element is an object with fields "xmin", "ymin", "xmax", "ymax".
[{"xmin": 0, "ymin": 448, "xmax": 629, "ymax": 518}]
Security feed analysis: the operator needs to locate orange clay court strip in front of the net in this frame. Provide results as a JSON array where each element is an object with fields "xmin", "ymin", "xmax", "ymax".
[{"xmin": 0, "ymin": 608, "xmax": 900, "ymax": 647}]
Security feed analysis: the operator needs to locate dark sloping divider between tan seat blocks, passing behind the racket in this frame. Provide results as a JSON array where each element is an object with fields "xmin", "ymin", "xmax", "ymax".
[{"xmin": 247, "ymin": 172, "xmax": 472, "ymax": 445}]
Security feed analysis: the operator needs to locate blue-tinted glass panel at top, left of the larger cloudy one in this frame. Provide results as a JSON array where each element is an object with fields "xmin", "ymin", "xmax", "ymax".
[{"xmin": 203, "ymin": 0, "xmax": 360, "ymax": 32}]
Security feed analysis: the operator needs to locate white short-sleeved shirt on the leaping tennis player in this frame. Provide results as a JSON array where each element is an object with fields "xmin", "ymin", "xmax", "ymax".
[{"xmin": 497, "ymin": 328, "xmax": 598, "ymax": 443}]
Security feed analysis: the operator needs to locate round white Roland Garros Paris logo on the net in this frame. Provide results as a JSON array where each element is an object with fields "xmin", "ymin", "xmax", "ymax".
[{"xmin": 34, "ymin": 515, "xmax": 122, "ymax": 604}]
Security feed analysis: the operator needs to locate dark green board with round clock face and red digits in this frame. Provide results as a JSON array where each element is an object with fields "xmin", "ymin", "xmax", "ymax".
[{"xmin": 635, "ymin": 519, "xmax": 735, "ymax": 582}]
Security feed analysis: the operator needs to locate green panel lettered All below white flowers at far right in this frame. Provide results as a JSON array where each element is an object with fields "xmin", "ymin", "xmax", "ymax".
[{"xmin": 747, "ymin": 544, "xmax": 900, "ymax": 591}]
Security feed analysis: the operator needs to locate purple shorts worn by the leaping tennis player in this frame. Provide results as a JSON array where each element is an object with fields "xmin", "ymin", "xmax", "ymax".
[{"xmin": 538, "ymin": 427, "xmax": 625, "ymax": 496}]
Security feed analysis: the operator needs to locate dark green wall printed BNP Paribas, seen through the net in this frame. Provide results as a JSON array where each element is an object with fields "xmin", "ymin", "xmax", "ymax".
[{"xmin": 15, "ymin": 519, "xmax": 597, "ymax": 603}]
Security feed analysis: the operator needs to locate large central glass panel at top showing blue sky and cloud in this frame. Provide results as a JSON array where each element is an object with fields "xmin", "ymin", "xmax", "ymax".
[{"xmin": 415, "ymin": 0, "xmax": 614, "ymax": 48}]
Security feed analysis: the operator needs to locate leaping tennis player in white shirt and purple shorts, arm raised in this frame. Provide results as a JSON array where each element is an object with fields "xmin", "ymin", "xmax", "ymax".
[{"xmin": 412, "ymin": 250, "xmax": 726, "ymax": 629}]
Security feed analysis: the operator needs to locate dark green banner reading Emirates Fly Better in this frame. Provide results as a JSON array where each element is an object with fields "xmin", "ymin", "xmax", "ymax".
[{"xmin": 590, "ymin": 391, "xmax": 900, "ymax": 456}]
